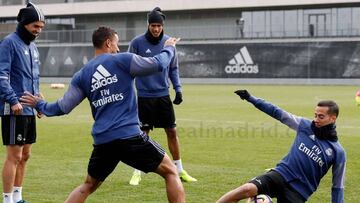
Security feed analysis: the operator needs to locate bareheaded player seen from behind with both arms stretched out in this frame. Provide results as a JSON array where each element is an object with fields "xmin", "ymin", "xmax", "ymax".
[{"xmin": 21, "ymin": 27, "xmax": 185, "ymax": 203}]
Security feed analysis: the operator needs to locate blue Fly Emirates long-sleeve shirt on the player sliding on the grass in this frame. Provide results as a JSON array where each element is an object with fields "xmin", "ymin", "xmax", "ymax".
[{"xmin": 248, "ymin": 96, "xmax": 346, "ymax": 203}]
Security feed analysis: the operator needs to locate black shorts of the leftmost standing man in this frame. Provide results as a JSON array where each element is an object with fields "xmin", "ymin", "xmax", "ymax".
[{"xmin": 1, "ymin": 115, "xmax": 36, "ymax": 145}]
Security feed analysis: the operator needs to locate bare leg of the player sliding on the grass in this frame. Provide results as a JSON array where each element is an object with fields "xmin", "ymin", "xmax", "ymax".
[{"xmin": 216, "ymin": 183, "xmax": 258, "ymax": 203}]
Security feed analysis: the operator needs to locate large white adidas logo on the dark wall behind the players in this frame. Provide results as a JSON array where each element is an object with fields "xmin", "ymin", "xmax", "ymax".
[{"xmin": 225, "ymin": 46, "xmax": 259, "ymax": 74}]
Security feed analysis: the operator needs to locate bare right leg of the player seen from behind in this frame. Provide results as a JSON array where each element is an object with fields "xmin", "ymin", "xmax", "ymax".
[{"xmin": 155, "ymin": 154, "xmax": 185, "ymax": 203}]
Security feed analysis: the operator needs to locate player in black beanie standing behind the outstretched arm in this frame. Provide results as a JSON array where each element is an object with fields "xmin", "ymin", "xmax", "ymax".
[{"xmin": 128, "ymin": 7, "xmax": 197, "ymax": 185}]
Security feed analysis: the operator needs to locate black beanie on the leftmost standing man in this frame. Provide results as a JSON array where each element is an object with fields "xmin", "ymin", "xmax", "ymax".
[{"xmin": 16, "ymin": 2, "xmax": 45, "ymax": 25}]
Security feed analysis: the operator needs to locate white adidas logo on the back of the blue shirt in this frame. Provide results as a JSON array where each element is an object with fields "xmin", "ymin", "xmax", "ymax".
[{"xmin": 91, "ymin": 64, "xmax": 118, "ymax": 92}]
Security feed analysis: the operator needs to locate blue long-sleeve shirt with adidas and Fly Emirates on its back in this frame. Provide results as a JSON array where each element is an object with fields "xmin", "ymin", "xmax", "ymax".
[{"xmin": 36, "ymin": 46, "xmax": 175, "ymax": 145}]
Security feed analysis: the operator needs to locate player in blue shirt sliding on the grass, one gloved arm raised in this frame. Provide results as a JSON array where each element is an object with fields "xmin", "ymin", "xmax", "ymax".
[{"xmin": 218, "ymin": 90, "xmax": 346, "ymax": 203}]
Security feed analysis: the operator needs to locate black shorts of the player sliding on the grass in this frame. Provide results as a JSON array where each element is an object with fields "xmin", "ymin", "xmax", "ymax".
[{"xmin": 249, "ymin": 170, "xmax": 305, "ymax": 203}]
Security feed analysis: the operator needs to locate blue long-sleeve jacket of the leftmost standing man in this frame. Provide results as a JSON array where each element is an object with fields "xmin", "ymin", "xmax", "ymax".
[{"xmin": 0, "ymin": 32, "xmax": 40, "ymax": 115}]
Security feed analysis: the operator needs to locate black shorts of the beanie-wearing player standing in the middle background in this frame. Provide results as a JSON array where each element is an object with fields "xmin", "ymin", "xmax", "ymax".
[{"xmin": 138, "ymin": 96, "xmax": 176, "ymax": 130}]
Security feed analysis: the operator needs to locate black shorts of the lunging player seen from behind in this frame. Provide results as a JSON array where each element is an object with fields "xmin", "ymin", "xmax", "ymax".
[{"xmin": 88, "ymin": 133, "xmax": 165, "ymax": 181}]
